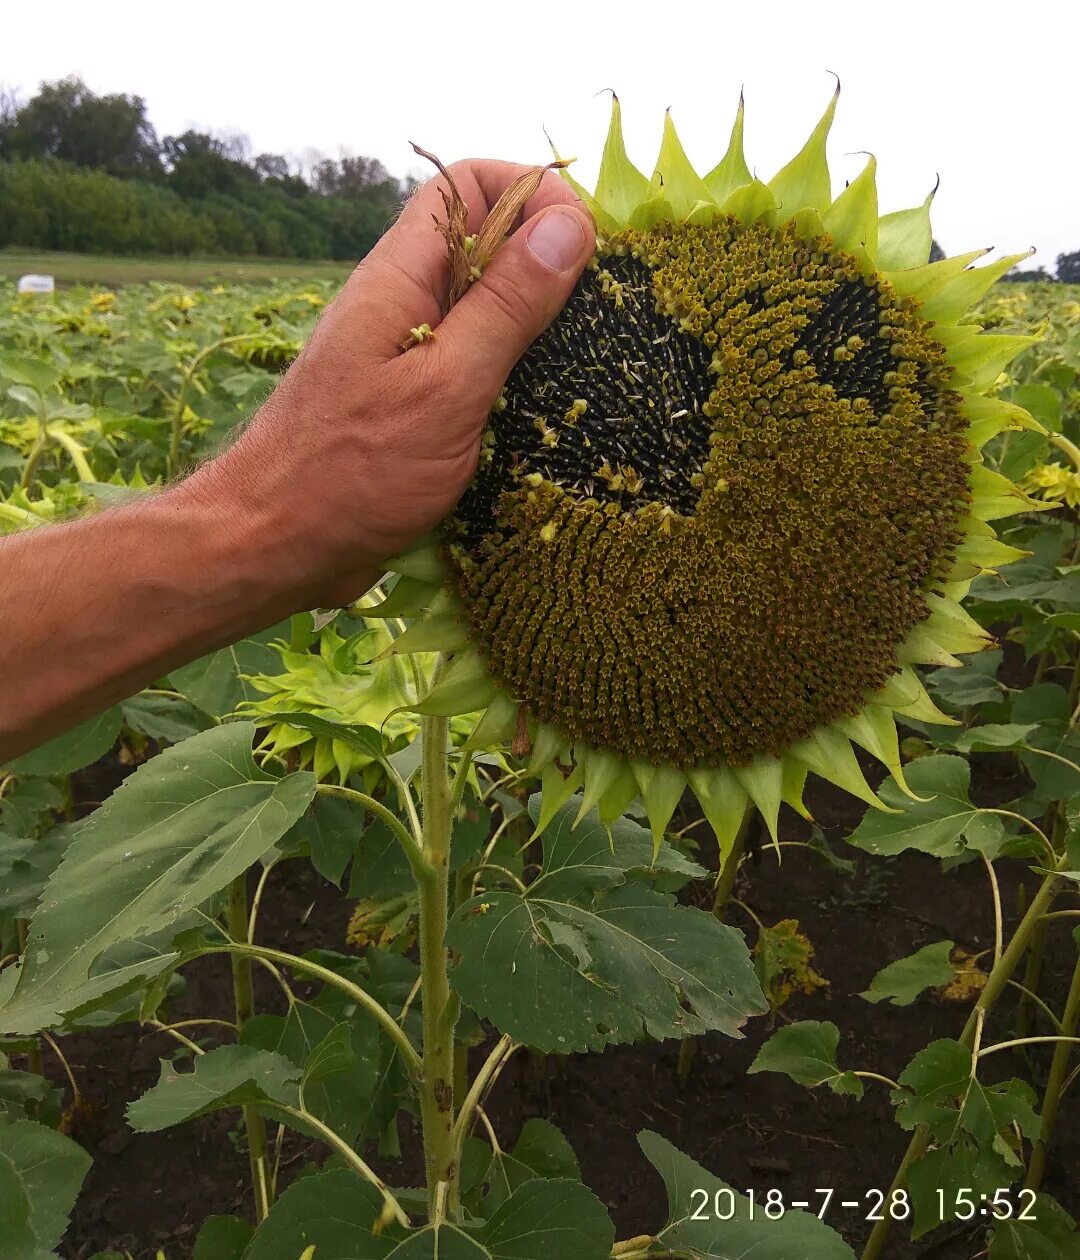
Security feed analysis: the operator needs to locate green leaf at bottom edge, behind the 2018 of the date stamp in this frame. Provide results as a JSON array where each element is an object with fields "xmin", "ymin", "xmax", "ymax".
[{"xmin": 638, "ymin": 1130, "xmax": 854, "ymax": 1260}]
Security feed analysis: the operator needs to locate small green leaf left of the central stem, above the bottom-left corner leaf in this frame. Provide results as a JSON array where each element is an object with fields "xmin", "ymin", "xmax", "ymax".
[{"xmin": 127, "ymin": 1046, "xmax": 301, "ymax": 1133}]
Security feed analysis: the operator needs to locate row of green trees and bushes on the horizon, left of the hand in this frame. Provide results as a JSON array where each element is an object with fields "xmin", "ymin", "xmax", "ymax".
[{"xmin": 0, "ymin": 78, "xmax": 408, "ymax": 258}]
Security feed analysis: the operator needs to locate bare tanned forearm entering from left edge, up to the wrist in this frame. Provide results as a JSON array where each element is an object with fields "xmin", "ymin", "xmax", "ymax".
[{"xmin": 0, "ymin": 465, "xmax": 377, "ymax": 764}]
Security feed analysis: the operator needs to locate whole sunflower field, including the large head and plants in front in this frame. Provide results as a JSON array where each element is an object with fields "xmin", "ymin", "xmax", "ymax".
[{"xmin": 0, "ymin": 95, "xmax": 1080, "ymax": 1260}]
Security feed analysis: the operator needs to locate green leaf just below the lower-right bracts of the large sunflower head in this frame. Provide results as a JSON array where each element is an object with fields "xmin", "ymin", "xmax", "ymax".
[{"xmin": 848, "ymin": 756, "xmax": 1004, "ymax": 858}]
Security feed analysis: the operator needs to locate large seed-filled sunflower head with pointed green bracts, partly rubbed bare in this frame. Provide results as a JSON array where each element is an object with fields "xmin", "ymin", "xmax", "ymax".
[{"xmin": 365, "ymin": 86, "xmax": 1035, "ymax": 853}]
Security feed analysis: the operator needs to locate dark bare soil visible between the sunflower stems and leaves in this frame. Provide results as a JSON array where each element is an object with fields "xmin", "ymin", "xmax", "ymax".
[{"xmin": 16, "ymin": 735, "xmax": 1080, "ymax": 1260}]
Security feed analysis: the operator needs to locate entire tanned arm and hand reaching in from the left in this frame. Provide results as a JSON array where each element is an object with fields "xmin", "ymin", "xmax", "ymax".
[{"xmin": 0, "ymin": 160, "xmax": 594, "ymax": 764}]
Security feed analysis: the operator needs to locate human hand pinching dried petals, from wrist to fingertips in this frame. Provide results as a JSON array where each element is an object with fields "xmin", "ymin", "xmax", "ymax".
[{"xmin": 187, "ymin": 160, "xmax": 594, "ymax": 609}]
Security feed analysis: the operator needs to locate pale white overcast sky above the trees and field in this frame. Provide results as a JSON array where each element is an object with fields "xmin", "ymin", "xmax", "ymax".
[{"xmin": 0, "ymin": 0, "xmax": 1080, "ymax": 270}]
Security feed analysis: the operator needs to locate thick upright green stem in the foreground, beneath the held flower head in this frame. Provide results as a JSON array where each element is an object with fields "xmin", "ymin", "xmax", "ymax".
[{"xmin": 417, "ymin": 695, "xmax": 457, "ymax": 1218}]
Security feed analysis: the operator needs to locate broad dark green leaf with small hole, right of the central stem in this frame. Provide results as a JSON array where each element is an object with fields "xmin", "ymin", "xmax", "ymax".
[{"xmin": 446, "ymin": 800, "xmax": 767, "ymax": 1053}]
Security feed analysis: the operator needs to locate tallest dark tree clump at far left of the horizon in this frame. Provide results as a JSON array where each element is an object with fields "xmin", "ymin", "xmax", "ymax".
[{"xmin": 0, "ymin": 78, "xmax": 161, "ymax": 176}]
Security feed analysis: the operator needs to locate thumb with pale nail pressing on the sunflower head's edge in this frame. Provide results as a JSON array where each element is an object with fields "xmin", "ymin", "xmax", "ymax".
[{"xmin": 439, "ymin": 205, "xmax": 595, "ymax": 404}]
